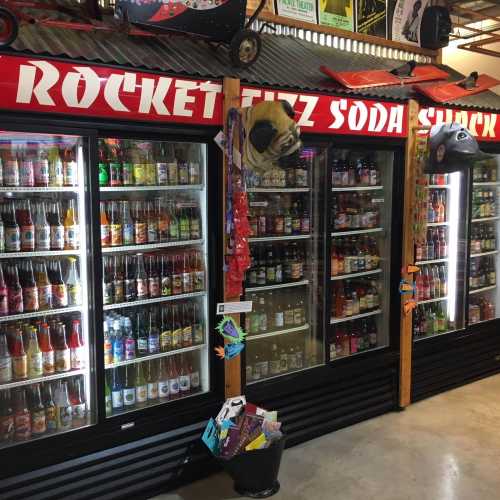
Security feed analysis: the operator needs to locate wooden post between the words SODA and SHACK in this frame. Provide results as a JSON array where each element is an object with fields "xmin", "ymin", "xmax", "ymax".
[{"xmin": 399, "ymin": 100, "xmax": 419, "ymax": 408}]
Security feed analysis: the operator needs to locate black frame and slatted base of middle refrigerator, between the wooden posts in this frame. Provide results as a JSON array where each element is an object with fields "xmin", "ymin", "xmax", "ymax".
[{"xmin": 241, "ymin": 134, "xmax": 405, "ymax": 446}]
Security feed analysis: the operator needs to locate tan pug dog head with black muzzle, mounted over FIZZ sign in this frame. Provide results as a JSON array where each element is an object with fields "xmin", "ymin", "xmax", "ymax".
[{"xmin": 242, "ymin": 101, "xmax": 302, "ymax": 174}]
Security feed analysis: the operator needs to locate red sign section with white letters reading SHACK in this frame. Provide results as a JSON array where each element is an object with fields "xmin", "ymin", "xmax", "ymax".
[{"xmin": 418, "ymin": 107, "xmax": 500, "ymax": 141}]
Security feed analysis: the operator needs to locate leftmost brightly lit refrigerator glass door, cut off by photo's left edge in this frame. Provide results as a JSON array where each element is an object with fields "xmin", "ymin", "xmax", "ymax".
[{"xmin": 0, "ymin": 130, "xmax": 96, "ymax": 446}]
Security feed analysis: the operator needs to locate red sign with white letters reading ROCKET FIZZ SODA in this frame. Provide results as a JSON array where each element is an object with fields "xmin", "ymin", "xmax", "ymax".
[{"xmin": 0, "ymin": 56, "xmax": 408, "ymax": 137}]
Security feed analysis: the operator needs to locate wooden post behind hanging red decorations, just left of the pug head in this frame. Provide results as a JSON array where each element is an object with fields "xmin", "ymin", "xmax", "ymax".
[{"xmin": 222, "ymin": 78, "xmax": 241, "ymax": 398}]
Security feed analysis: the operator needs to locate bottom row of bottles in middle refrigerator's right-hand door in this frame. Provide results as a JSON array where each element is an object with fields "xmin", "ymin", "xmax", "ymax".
[{"xmin": 329, "ymin": 318, "xmax": 378, "ymax": 361}]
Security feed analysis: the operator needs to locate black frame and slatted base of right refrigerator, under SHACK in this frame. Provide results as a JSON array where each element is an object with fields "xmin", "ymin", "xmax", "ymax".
[{"xmin": 411, "ymin": 142, "xmax": 500, "ymax": 403}]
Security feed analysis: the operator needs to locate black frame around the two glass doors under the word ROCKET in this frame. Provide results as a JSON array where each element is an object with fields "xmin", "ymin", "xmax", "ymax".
[{"xmin": 0, "ymin": 111, "xmax": 224, "ymax": 480}]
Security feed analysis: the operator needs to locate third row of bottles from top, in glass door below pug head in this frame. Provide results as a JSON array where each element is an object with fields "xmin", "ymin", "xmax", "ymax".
[{"xmin": 246, "ymin": 243, "xmax": 306, "ymax": 287}]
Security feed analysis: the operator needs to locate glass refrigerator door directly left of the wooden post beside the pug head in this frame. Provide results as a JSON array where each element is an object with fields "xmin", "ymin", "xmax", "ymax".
[{"xmin": 98, "ymin": 138, "xmax": 210, "ymax": 417}]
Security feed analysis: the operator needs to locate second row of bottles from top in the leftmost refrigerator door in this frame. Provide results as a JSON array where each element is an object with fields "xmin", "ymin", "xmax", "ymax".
[{"xmin": 0, "ymin": 199, "xmax": 80, "ymax": 252}]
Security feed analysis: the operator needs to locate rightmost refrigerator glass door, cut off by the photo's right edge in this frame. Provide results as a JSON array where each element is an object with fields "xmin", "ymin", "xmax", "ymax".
[{"xmin": 469, "ymin": 155, "xmax": 500, "ymax": 325}]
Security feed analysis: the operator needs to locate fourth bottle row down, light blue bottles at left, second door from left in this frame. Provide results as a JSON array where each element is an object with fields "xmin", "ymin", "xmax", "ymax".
[{"xmin": 103, "ymin": 302, "xmax": 205, "ymax": 365}]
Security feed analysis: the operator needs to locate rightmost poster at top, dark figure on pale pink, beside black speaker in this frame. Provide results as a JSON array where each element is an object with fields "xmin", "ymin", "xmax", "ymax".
[{"xmin": 392, "ymin": 0, "xmax": 429, "ymax": 46}]
